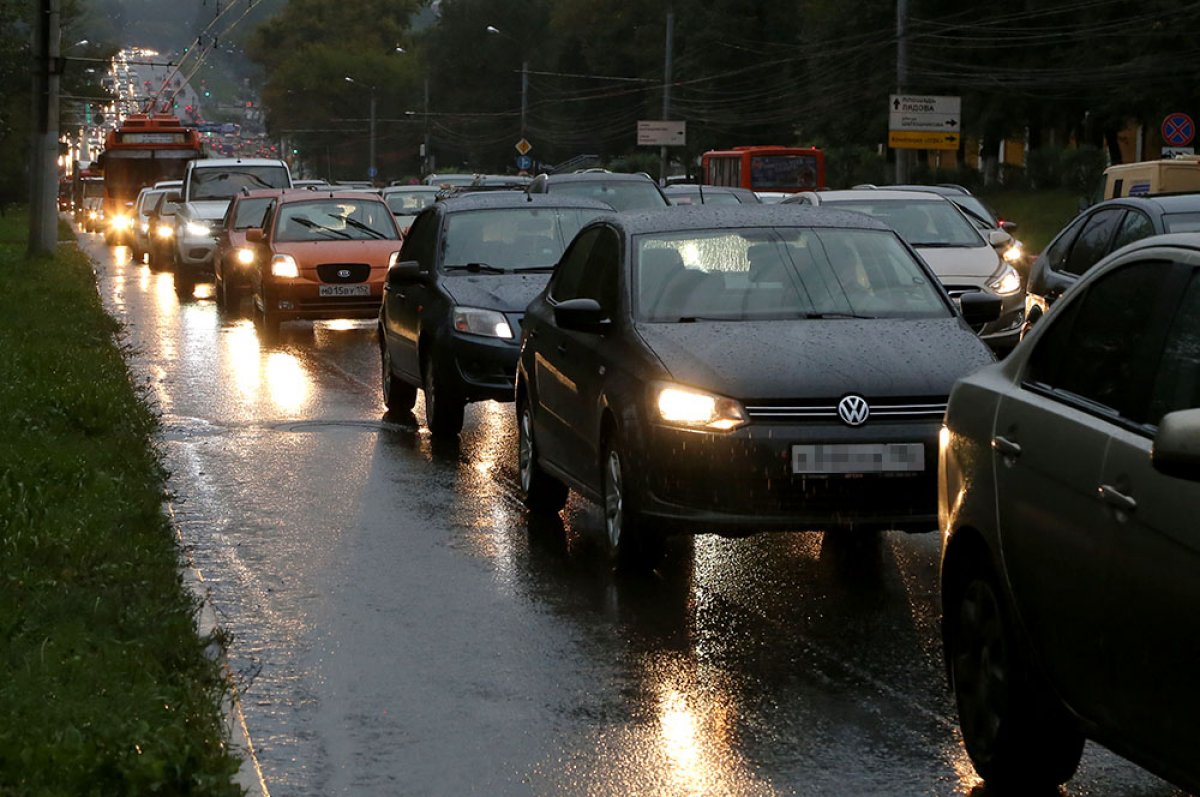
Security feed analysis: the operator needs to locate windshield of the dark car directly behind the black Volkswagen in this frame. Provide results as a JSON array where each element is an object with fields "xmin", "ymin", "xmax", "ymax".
[{"xmin": 442, "ymin": 206, "xmax": 604, "ymax": 271}]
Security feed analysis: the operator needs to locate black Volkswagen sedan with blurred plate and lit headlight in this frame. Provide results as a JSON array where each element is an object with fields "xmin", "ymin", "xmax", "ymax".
[{"xmin": 516, "ymin": 206, "xmax": 998, "ymax": 567}]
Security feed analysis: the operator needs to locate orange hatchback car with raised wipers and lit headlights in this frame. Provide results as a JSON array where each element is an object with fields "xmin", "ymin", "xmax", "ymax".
[{"xmin": 246, "ymin": 191, "xmax": 401, "ymax": 334}]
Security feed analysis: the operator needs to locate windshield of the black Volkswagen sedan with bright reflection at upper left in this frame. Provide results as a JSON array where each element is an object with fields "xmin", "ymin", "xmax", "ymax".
[{"xmin": 632, "ymin": 228, "xmax": 952, "ymax": 323}]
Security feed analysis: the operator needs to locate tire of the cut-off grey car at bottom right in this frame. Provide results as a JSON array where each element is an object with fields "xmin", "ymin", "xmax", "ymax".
[{"xmin": 947, "ymin": 568, "xmax": 1084, "ymax": 793}]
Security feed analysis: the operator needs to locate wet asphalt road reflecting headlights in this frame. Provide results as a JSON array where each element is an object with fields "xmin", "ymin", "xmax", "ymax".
[{"xmin": 84, "ymin": 235, "xmax": 1177, "ymax": 797}]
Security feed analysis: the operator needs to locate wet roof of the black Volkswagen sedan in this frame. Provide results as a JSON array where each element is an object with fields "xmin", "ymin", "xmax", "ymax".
[{"xmin": 590, "ymin": 205, "xmax": 892, "ymax": 235}]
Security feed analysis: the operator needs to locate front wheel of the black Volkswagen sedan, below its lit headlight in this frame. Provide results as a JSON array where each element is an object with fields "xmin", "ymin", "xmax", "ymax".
[{"xmin": 600, "ymin": 435, "xmax": 666, "ymax": 571}]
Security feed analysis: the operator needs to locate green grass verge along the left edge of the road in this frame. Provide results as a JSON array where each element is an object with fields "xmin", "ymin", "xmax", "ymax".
[{"xmin": 0, "ymin": 211, "xmax": 241, "ymax": 796}]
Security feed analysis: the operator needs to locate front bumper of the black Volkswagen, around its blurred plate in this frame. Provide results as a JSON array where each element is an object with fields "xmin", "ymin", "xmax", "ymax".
[{"xmin": 638, "ymin": 420, "xmax": 941, "ymax": 534}]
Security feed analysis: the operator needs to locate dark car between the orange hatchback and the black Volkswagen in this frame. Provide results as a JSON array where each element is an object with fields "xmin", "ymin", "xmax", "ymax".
[{"xmin": 379, "ymin": 192, "xmax": 612, "ymax": 437}]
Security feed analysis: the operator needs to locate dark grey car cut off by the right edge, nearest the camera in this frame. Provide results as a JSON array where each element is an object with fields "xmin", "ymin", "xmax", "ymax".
[{"xmin": 938, "ymin": 234, "xmax": 1200, "ymax": 793}]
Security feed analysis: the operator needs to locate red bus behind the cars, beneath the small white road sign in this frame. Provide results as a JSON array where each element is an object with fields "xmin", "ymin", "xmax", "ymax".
[{"xmin": 701, "ymin": 146, "xmax": 824, "ymax": 193}]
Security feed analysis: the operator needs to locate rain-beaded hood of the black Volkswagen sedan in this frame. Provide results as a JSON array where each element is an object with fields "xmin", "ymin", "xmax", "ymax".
[{"xmin": 636, "ymin": 318, "xmax": 995, "ymax": 400}]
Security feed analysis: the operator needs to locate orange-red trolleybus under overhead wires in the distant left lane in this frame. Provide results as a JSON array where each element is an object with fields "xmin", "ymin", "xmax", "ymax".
[{"xmin": 97, "ymin": 114, "xmax": 204, "ymax": 244}]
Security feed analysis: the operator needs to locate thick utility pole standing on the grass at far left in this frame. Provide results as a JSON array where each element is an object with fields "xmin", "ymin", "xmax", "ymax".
[{"xmin": 29, "ymin": 0, "xmax": 62, "ymax": 254}]
